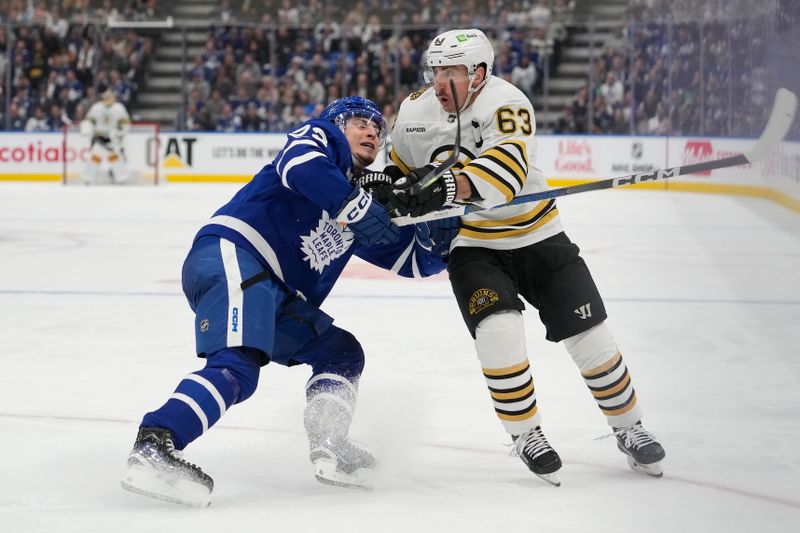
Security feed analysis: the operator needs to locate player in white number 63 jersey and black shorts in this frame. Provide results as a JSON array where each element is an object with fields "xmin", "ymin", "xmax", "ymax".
[{"xmin": 387, "ymin": 29, "xmax": 665, "ymax": 485}]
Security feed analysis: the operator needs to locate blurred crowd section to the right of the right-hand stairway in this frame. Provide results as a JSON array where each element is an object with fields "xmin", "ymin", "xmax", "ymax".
[{"xmin": 554, "ymin": 0, "xmax": 788, "ymax": 136}]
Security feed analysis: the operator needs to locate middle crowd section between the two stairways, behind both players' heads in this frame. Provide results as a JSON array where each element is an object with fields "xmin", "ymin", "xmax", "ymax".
[{"xmin": 184, "ymin": 0, "xmax": 574, "ymax": 131}]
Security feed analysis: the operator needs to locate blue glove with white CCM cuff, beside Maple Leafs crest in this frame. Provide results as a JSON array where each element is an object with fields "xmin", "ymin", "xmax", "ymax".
[{"xmin": 336, "ymin": 187, "xmax": 400, "ymax": 246}]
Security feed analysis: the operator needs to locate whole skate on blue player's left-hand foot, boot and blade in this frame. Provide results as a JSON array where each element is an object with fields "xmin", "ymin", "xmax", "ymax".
[{"xmin": 121, "ymin": 428, "xmax": 214, "ymax": 507}]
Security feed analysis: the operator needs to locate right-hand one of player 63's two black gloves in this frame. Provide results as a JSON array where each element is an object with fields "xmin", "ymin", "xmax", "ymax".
[{"xmin": 391, "ymin": 165, "xmax": 456, "ymax": 217}]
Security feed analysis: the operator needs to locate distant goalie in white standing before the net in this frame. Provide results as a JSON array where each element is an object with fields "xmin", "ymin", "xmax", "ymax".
[{"xmin": 81, "ymin": 89, "xmax": 131, "ymax": 185}]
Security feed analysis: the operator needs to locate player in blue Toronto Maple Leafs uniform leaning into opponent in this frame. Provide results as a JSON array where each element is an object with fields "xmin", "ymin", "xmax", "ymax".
[{"xmin": 122, "ymin": 97, "xmax": 455, "ymax": 506}]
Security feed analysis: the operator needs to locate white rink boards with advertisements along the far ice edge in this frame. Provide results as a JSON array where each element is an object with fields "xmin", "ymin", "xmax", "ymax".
[{"xmin": 0, "ymin": 128, "xmax": 800, "ymax": 205}]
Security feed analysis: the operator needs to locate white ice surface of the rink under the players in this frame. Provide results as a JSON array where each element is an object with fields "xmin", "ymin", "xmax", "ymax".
[{"xmin": 0, "ymin": 184, "xmax": 800, "ymax": 533}]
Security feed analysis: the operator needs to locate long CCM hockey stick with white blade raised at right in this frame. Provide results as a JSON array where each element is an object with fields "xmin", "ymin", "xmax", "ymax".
[{"xmin": 392, "ymin": 89, "xmax": 797, "ymax": 226}]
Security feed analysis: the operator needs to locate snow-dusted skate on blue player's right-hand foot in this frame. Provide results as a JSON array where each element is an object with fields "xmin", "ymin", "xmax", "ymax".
[{"xmin": 310, "ymin": 437, "xmax": 375, "ymax": 490}]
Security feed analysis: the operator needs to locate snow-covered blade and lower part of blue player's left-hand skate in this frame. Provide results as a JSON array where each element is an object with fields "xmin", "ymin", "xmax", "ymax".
[{"xmin": 120, "ymin": 466, "xmax": 211, "ymax": 507}]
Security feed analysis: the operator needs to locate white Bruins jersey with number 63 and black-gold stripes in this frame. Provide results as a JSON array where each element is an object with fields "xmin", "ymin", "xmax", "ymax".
[{"xmin": 390, "ymin": 76, "xmax": 562, "ymax": 250}]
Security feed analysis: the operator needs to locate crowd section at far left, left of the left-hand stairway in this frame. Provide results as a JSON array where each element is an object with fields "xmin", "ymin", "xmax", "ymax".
[{"xmin": 0, "ymin": 0, "xmax": 156, "ymax": 131}]
